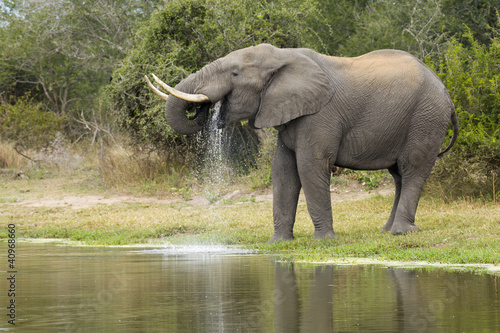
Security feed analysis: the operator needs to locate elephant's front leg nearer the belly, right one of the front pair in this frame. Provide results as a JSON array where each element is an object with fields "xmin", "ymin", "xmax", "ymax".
[{"xmin": 298, "ymin": 158, "xmax": 337, "ymax": 238}]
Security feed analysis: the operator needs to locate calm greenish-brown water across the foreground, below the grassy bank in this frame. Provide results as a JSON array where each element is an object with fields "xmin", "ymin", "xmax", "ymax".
[{"xmin": 0, "ymin": 242, "xmax": 500, "ymax": 332}]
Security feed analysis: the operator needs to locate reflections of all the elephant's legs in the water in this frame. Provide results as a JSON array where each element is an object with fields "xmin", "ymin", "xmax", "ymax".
[{"xmin": 274, "ymin": 262, "xmax": 436, "ymax": 332}]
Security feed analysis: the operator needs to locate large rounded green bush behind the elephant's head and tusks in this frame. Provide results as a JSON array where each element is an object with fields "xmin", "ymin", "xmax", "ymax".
[{"xmin": 106, "ymin": 0, "xmax": 317, "ymax": 149}]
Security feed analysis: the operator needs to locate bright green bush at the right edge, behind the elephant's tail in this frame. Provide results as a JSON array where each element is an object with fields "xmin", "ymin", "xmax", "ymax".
[{"xmin": 428, "ymin": 31, "xmax": 500, "ymax": 198}]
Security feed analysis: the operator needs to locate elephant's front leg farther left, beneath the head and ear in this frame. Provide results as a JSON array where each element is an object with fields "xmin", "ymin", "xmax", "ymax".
[{"xmin": 269, "ymin": 137, "xmax": 301, "ymax": 243}]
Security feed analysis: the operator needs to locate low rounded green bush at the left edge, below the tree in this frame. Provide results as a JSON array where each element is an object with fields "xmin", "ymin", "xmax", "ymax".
[{"xmin": 0, "ymin": 96, "xmax": 63, "ymax": 148}]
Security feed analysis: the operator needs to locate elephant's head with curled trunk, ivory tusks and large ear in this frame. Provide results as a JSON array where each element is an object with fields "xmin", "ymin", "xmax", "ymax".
[{"xmin": 146, "ymin": 44, "xmax": 333, "ymax": 134}]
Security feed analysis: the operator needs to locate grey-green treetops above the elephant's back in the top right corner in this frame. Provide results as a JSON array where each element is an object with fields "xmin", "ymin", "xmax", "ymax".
[{"xmin": 330, "ymin": 0, "xmax": 500, "ymax": 59}]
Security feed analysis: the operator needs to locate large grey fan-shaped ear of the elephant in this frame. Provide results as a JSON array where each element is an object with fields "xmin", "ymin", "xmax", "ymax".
[{"xmin": 255, "ymin": 49, "xmax": 334, "ymax": 128}]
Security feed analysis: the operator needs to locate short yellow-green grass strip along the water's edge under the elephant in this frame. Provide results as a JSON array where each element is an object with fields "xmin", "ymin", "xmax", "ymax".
[{"xmin": 0, "ymin": 179, "xmax": 500, "ymax": 264}]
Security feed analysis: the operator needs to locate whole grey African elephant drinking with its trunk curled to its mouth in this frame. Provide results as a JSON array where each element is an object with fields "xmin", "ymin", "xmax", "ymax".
[{"xmin": 146, "ymin": 44, "xmax": 458, "ymax": 242}]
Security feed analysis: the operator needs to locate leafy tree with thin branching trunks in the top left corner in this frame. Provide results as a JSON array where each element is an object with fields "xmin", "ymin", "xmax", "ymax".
[{"xmin": 0, "ymin": 0, "xmax": 159, "ymax": 115}]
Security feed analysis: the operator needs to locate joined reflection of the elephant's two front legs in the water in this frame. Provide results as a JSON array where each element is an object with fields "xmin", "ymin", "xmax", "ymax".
[{"xmin": 274, "ymin": 262, "xmax": 333, "ymax": 332}]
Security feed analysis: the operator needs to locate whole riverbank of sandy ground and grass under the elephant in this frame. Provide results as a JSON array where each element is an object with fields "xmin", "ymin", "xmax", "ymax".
[{"xmin": 0, "ymin": 170, "xmax": 500, "ymax": 267}]
